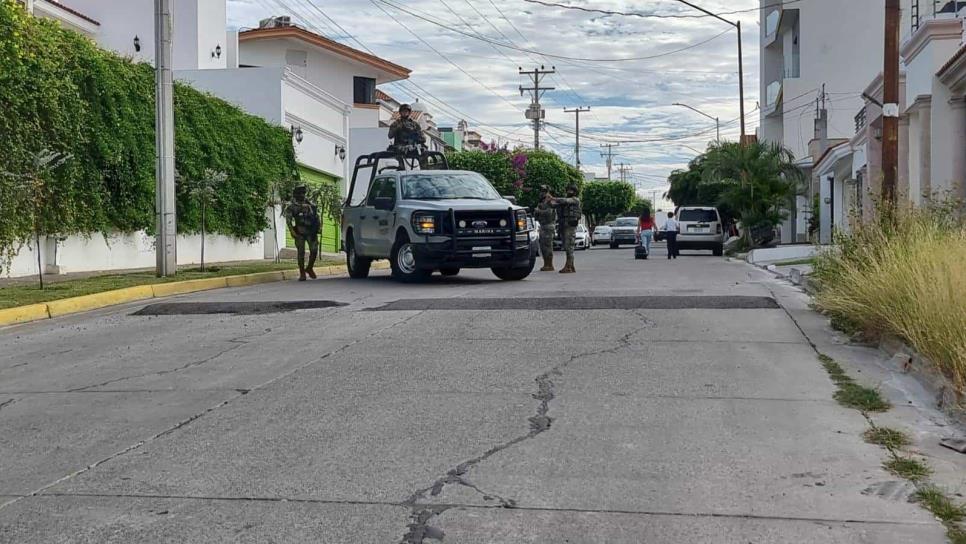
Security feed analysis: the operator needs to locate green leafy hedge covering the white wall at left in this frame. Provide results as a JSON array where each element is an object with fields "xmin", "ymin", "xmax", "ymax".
[{"xmin": 0, "ymin": 0, "xmax": 297, "ymax": 266}]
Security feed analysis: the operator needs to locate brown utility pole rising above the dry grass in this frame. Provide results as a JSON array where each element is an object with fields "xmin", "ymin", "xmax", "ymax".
[{"xmin": 882, "ymin": 0, "xmax": 900, "ymax": 211}]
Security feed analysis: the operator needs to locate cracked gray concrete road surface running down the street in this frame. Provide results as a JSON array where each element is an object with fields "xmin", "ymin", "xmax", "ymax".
[{"xmin": 0, "ymin": 247, "xmax": 944, "ymax": 544}]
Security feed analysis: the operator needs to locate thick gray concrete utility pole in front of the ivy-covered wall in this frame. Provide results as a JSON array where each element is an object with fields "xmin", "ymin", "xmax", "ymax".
[{"xmin": 154, "ymin": 0, "xmax": 178, "ymax": 277}]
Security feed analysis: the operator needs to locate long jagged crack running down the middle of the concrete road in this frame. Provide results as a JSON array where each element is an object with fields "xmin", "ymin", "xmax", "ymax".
[{"xmin": 400, "ymin": 311, "xmax": 654, "ymax": 544}]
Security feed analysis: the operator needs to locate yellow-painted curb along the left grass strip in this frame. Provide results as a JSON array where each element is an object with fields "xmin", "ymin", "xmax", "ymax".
[{"xmin": 0, "ymin": 261, "xmax": 389, "ymax": 327}]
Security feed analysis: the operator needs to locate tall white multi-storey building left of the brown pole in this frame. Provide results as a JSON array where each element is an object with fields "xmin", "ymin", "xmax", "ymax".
[{"xmin": 758, "ymin": 0, "xmax": 885, "ymax": 243}]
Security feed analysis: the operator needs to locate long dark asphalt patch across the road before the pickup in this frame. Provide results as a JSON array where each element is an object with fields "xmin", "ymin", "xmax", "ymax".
[{"xmin": 367, "ymin": 296, "xmax": 779, "ymax": 312}]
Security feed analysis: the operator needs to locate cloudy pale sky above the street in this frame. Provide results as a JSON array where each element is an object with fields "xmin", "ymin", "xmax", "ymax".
[{"xmin": 228, "ymin": 0, "xmax": 759, "ymax": 197}]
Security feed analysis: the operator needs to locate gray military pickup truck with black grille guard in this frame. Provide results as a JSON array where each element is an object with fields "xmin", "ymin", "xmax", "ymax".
[{"xmin": 342, "ymin": 152, "xmax": 537, "ymax": 282}]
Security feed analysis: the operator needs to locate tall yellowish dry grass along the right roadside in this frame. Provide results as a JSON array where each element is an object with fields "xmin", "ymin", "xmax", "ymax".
[{"xmin": 815, "ymin": 207, "xmax": 966, "ymax": 390}]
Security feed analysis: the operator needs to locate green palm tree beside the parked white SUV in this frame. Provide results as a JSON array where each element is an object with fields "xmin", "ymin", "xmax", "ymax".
[{"xmin": 702, "ymin": 142, "xmax": 805, "ymax": 243}]
